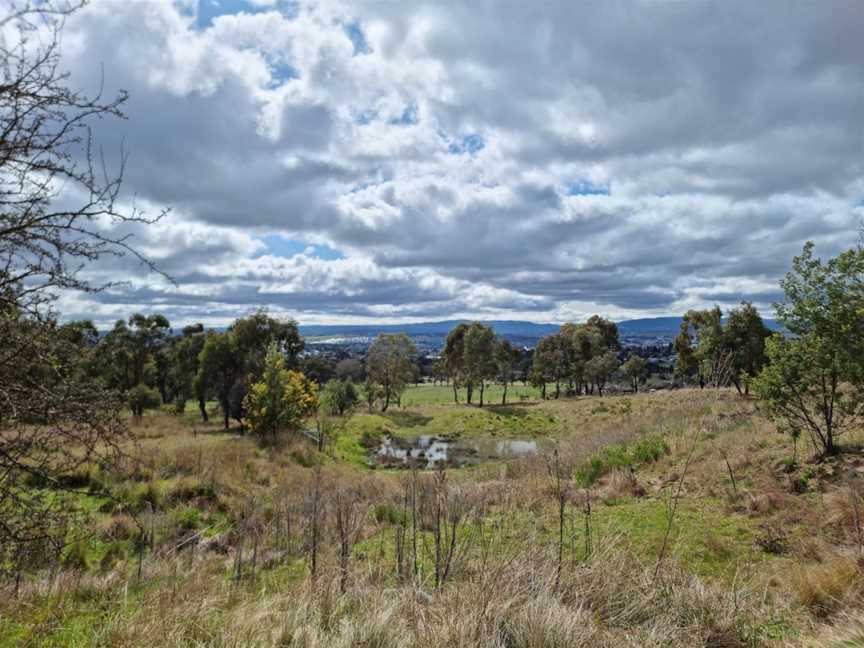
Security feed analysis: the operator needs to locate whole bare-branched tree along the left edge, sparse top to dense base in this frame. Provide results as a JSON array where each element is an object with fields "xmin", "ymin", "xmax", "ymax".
[{"xmin": 0, "ymin": 0, "xmax": 161, "ymax": 562}]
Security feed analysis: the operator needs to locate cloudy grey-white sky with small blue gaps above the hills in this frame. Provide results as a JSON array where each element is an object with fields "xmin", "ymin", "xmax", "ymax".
[{"xmin": 52, "ymin": 0, "xmax": 864, "ymax": 326}]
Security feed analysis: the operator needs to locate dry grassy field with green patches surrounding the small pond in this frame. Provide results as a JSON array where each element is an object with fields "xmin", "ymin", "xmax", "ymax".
[{"xmin": 0, "ymin": 386, "xmax": 864, "ymax": 648}]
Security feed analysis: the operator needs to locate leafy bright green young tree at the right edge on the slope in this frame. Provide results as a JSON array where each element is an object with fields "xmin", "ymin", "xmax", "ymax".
[{"xmin": 754, "ymin": 242, "xmax": 864, "ymax": 457}]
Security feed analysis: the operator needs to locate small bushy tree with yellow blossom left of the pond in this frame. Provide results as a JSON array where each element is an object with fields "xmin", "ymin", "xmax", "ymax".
[{"xmin": 243, "ymin": 343, "xmax": 318, "ymax": 442}]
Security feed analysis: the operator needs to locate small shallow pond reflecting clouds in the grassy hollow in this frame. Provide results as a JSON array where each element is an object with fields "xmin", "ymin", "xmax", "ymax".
[{"xmin": 370, "ymin": 435, "xmax": 538, "ymax": 469}]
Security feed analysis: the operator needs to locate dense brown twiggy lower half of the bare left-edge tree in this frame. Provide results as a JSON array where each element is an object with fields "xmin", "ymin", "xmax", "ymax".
[{"xmin": 0, "ymin": 305, "xmax": 126, "ymax": 562}]
